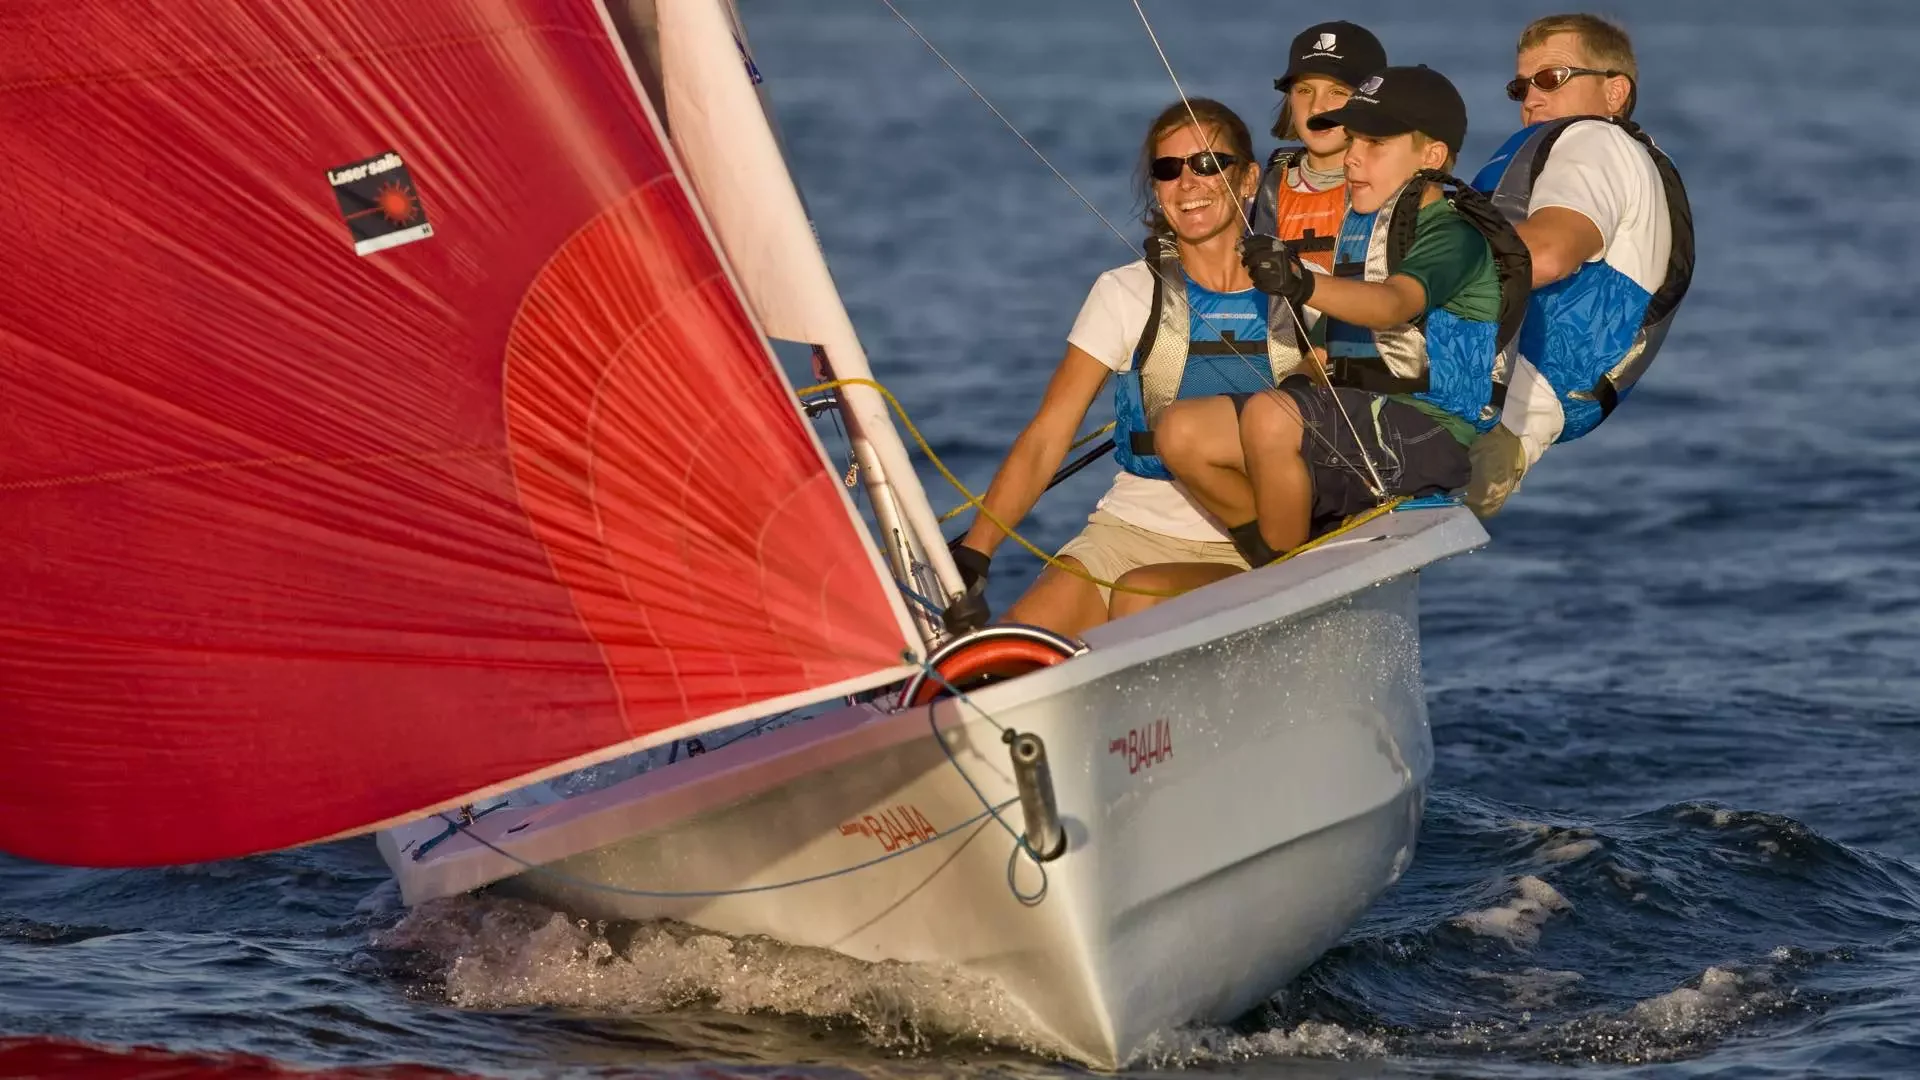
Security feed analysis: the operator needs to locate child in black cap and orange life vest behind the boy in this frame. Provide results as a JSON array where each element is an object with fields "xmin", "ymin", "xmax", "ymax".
[{"xmin": 1254, "ymin": 21, "xmax": 1386, "ymax": 271}]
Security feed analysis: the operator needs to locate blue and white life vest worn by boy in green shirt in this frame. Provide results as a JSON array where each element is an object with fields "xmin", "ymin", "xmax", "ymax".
[{"xmin": 1327, "ymin": 169, "xmax": 1532, "ymax": 430}]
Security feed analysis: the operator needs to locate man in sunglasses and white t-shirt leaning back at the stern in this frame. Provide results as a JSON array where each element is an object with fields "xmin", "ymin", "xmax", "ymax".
[{"xmin": 1467, "ymin": 13, "xmax": 1693, "ymax": 517}]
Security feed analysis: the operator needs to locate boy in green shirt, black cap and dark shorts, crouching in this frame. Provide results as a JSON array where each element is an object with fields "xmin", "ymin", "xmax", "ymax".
[{"xmin": 1114, "ymin": 67, "xmax": 1524, "ymax": 617}]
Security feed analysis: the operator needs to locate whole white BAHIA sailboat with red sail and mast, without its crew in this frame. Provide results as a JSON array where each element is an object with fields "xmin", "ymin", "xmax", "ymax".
[{"xmin": 0, "ymin": 0, "xmax": 1486, "ymax": 1068}]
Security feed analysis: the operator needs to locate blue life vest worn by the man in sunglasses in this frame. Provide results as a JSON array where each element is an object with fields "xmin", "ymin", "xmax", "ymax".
[{"xmin": 1473, "ymin": 115, "xmax": 1693, "ymax": 442}]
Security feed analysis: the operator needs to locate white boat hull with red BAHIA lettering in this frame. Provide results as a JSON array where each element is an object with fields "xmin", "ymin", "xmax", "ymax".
[{"xmin": 380, "ymin": 509, "xmax": 1486, "ymax": 1068}]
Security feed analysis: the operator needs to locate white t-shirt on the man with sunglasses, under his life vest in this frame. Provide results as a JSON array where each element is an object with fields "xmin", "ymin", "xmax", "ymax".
[{"xmin": 1500, "ymin": 119, "xmax": 1674, "ymax": 461}]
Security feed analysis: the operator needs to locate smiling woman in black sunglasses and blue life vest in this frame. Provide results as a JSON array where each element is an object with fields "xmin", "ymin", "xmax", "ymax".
[{"xmin": 954, "ymin": 98, "xmax": 1300, "ymax": 634}]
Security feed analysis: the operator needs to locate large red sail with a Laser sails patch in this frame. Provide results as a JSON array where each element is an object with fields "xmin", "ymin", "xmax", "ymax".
[{"xmin": 0, "ymin": 0, "xmax": 912, "ymax": 865}]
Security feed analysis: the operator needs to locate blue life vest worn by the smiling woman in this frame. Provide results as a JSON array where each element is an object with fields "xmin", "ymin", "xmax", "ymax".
[{"xmin": 1114, "ymin": 236, "xmax": 1300, "ymax": 480}]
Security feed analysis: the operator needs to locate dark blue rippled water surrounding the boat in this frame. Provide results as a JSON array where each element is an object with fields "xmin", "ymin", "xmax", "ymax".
[{"xmin": 0, "ymin": 0, "xmax": 1920, "ymax": 1076}]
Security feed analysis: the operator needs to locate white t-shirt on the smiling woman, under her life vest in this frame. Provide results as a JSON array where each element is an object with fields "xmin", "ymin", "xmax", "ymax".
[{"xmin": 1068, "ymin": 259, "xmax": 1229, "ymax": 544}]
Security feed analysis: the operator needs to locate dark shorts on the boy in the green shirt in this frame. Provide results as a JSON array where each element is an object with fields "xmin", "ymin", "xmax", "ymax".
[{"xmin": 1233, "ymin": 375, "xmax": 1471, "ymax": 536}]
